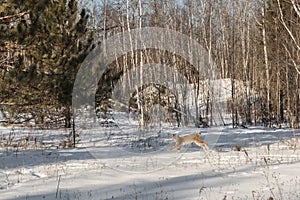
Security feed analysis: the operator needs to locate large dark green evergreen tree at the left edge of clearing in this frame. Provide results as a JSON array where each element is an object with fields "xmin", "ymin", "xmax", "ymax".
[{"xmin": 0, "ymin": 0, "xmax": 92, "ymax": 127}]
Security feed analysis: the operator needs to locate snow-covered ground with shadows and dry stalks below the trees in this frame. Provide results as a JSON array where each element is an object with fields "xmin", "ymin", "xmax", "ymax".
[{"xmin": 0, "ymin": 124, "xmax": 300, "ymax": 200}]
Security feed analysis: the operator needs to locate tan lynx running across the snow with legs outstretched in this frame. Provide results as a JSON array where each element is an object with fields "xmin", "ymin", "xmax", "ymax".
[{"xmin": 168, "ymin": 133, "xmax": 208, "ymax": 151}]
